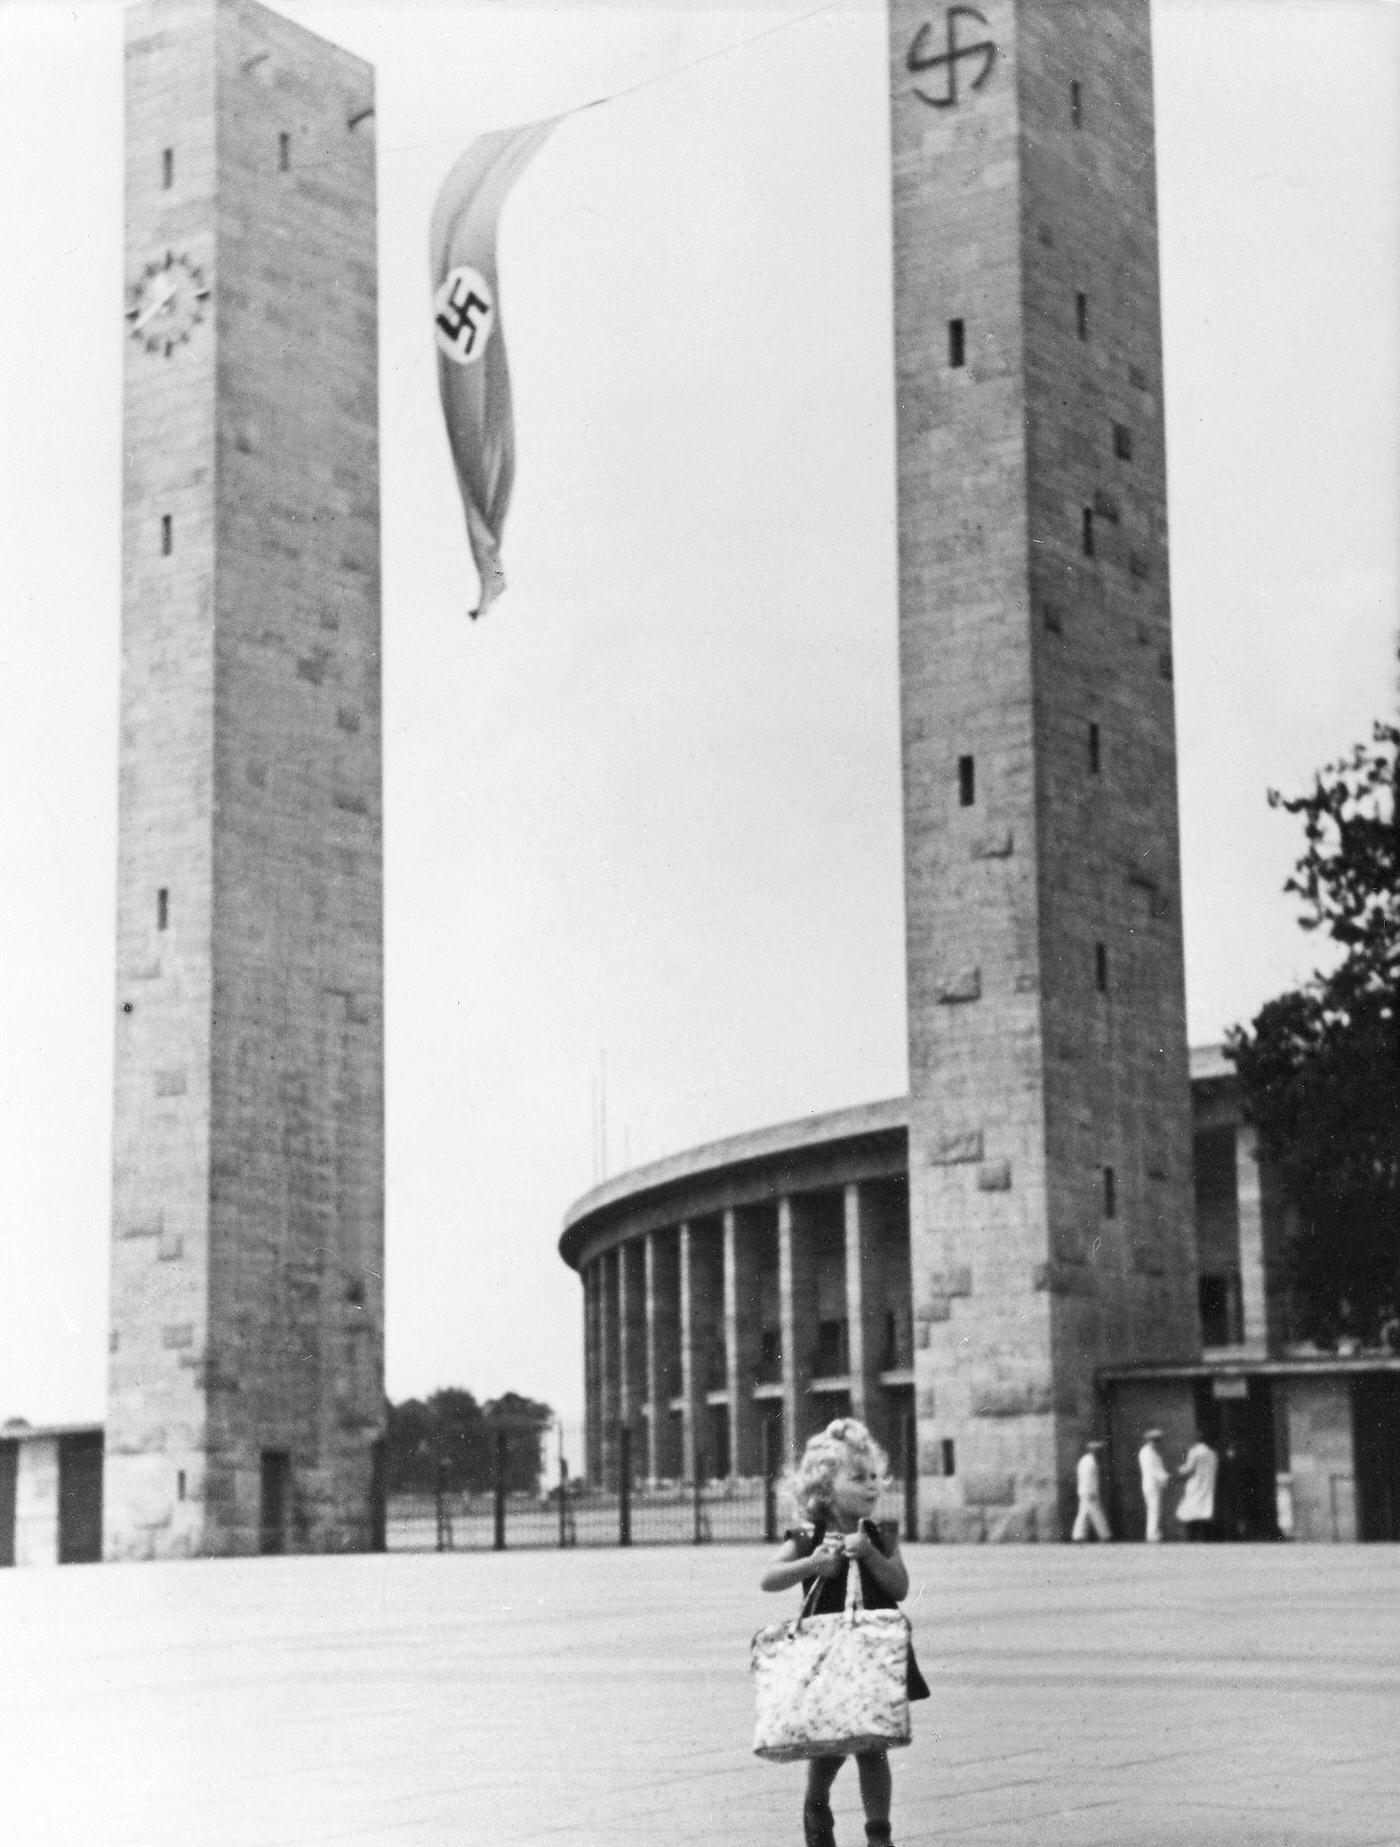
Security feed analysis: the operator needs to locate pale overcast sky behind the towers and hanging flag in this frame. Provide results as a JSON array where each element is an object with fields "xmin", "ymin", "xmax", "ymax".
[{"xmin": 0, "ymin": 0, "xmax": 1400, "ymax": 1422}]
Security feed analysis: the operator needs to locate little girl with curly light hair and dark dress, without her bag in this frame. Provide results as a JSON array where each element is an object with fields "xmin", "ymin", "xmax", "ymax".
[{"xmin": 763, "ymin": 1417, "xmax": 929, "ymax": 1847}]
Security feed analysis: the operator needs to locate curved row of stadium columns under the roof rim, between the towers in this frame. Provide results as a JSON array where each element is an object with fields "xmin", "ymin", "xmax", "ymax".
[{"xmin": 580, "ymin": 1175, "xmax": 912, "ymax": 1487}]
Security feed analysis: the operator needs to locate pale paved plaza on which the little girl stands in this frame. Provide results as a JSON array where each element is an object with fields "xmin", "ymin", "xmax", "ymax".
[{"xmin": 0, "ymin": 1544, "xmax": 1400, "ymax": 1847}]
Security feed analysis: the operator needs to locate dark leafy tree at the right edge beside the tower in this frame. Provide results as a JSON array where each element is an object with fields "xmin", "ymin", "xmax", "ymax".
[{"xmin": 1226, "ymin": 705, "xmax": 1400, "ymax": 1343}]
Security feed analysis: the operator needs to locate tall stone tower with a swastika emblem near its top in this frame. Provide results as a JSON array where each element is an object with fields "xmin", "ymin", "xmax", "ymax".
[{"xmin": 890, "ymin": 0, "xmax": 1197, "ymax": 1539}]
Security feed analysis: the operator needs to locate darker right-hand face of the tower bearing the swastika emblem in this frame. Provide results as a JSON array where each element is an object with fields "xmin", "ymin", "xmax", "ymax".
[{"xmin": 1018, "ymin": 0, "xmax": 1199, "ymax": 1479}]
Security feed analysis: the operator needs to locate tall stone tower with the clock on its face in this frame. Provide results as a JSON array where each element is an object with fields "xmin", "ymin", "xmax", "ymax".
[{"xmin": 105, "ymin": 0, "xmax": 384, "ymax": 1559}]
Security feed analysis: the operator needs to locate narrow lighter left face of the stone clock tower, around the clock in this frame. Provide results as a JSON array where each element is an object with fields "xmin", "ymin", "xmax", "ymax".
[{"xmin": 103, "ymin": 0, "xmax": 216, "ymax": 1557}]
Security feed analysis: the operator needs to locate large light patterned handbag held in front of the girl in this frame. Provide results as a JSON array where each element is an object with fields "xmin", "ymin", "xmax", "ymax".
[{"xmin": 750, "ymin": 1559, "xmax": 909, "ymax": 1764}]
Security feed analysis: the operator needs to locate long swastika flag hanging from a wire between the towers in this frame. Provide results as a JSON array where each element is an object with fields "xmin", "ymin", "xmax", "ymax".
[{"xmin": 428, "ymin": 116, "xmax": 558, "ymax": 617}]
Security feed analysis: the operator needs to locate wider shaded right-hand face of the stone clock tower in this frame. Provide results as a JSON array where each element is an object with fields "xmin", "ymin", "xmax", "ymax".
[{"xmin": 211, "ymin": 4, "xmax": 384, "ymax": 1551}]
